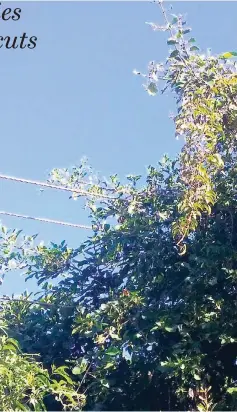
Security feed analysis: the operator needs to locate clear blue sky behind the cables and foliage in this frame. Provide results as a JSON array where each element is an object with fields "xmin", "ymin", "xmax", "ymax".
[{"xmin": 0, "ymin": 1, "xmax": 237, "ymax": 294}]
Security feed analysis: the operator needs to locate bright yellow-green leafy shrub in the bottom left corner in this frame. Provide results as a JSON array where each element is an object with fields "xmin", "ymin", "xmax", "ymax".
[{"xmin": 0, "ymin": 322, "xmax": 84, "ymax": 410}]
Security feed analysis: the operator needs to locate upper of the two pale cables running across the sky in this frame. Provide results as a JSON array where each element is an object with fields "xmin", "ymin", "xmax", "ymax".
[{"xmin": 0, "ymin": 174, "xmax": 116, "ymax": 200}]
